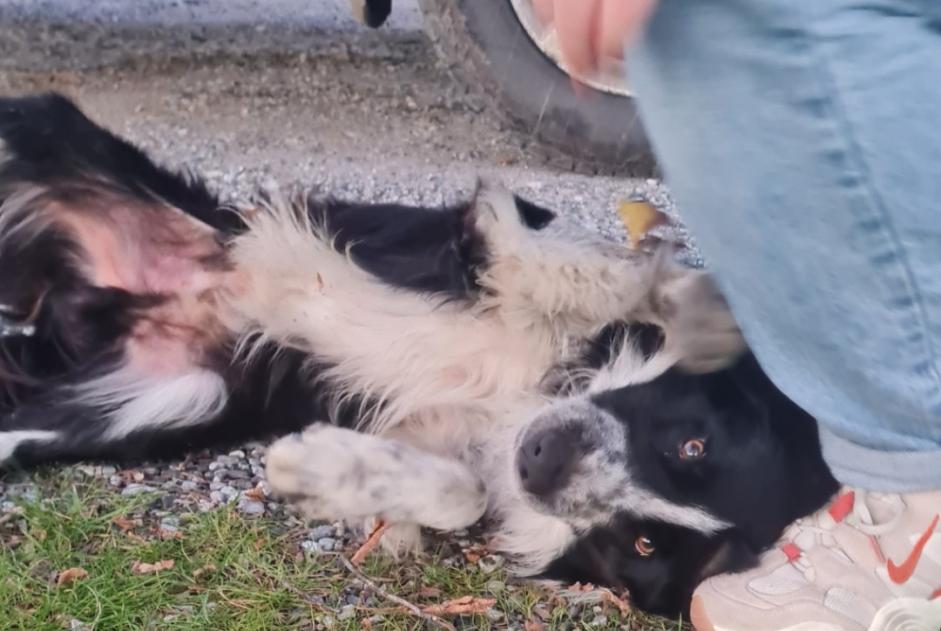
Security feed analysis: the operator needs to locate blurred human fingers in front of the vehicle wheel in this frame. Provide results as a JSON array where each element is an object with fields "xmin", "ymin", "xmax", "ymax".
[{"xmin": 532, "ymin": 0, "xmax": 657, "ymax": 84}]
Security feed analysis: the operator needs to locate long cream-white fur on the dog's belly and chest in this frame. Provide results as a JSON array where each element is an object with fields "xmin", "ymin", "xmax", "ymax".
[{"xmin": 226, "ymin": 193, "xmax": 560, "ymax": 432}]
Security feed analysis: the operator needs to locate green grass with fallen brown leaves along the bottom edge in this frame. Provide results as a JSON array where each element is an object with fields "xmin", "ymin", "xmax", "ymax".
[{"xmin": 0, "ymin": 470, "xmax": 682, "ymax": 631}]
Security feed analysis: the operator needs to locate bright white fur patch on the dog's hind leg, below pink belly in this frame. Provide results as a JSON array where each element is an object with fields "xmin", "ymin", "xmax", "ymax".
[{"xmin": 75, "ymin": 370, "xmax": 228, "ymax": 440}]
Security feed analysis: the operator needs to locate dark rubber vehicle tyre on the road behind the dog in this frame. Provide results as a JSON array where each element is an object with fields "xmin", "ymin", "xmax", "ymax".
[{"xmin": 419, "ymin": 0, "xmax": 656, "ymax": 177}]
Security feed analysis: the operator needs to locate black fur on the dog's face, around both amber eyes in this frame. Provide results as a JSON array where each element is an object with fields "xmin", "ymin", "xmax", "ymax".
[{"xmin": 547, "ymin": 354, "xmax": 838, "ymax": 615}]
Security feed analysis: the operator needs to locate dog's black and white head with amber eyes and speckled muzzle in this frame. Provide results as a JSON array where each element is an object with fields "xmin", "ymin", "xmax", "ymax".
[{"xmin": 515, "ymin": 354, "xmax": 836, "ymax": 615}]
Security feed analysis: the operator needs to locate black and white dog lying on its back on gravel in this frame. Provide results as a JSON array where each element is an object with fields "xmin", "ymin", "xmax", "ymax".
[{"xmin": 0, "ymin": 95, "xmax": 836, "ymax": 615}]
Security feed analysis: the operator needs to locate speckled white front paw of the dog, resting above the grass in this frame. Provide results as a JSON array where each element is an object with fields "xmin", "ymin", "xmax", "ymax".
[{"xmin": 267, "ymin": 426, "xmax": 487, "ymax": 535}]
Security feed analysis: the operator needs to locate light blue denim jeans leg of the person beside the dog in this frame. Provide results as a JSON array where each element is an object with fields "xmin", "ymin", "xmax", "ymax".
[{"xmin": 625, "ymin": 0, "xmax": 941, "ymax": 491}]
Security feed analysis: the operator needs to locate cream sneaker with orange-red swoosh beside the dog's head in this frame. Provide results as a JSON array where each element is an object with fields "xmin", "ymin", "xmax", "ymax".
[{"xmin": 690, "ymin": 489, "xmax": 941, "ymax": 631}]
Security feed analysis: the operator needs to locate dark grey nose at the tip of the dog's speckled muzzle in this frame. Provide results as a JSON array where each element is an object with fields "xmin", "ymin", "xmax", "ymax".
[{"xmin": 516, "ymin": 429, "xmax": 579, "ymax": 496}]
